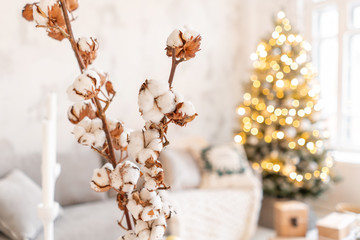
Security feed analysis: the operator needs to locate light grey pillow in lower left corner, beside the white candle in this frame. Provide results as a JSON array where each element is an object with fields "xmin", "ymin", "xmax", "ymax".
[{"xmin": 0, "ymin": 169, "xmax": 42, "ymax": 240}]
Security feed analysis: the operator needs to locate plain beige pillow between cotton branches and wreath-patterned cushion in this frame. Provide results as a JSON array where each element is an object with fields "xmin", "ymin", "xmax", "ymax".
[{"xmin": 160, "ymin": 148, "xmax": 201, "ymax": 190}]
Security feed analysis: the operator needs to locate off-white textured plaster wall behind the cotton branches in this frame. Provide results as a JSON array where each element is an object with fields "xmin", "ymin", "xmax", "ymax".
[{"xmin": 0, "ymin": 0, "xmax": 297, "ymax": 154}]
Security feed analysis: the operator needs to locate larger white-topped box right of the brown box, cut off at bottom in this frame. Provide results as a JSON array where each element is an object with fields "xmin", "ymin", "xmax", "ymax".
[{"xmin": 316, "ymin": 212, "xmax": 356, "ymax": 240}]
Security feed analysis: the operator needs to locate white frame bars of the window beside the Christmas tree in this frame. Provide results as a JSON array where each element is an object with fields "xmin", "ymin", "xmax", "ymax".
[{"xmin": 304, "ymin": 0, "xmax": 360, "ymax": 153}]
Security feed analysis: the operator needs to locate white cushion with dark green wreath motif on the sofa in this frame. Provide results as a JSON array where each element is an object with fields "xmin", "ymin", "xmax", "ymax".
[{"xmin": 200, "ymin": 144, "xmax": 257, "ymax": 188}]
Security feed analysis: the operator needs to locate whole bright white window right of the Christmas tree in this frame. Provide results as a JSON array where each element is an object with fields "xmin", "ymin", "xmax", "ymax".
[{"xmin": 311, "ymin": 0, "xmax": 360, "ymax": 151}]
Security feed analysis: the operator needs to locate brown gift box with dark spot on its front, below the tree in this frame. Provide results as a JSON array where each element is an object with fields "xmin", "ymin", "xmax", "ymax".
[{"xmin": 274, "ymin": 201, "xmax": 309, "ymax": 238}]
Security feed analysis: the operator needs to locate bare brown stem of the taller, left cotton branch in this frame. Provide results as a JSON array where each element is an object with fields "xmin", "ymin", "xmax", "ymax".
[{"xmin": 60, "ymin": 0, "xmax": 132, "ymax": 230}]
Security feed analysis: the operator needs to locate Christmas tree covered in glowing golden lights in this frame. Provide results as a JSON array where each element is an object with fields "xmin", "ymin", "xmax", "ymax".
[{"xmin": 234, "ymin": 11, "xmax": 336, "ymax": 198}]
